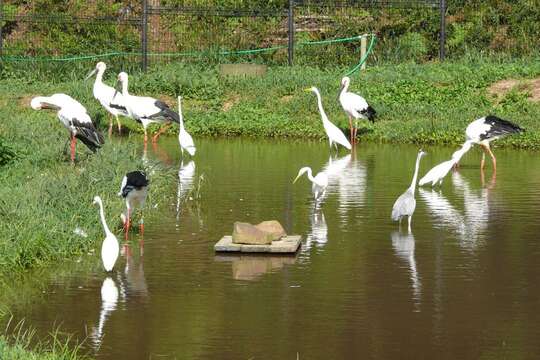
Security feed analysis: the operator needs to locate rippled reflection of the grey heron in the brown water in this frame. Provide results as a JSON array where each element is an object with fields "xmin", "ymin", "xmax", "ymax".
[{"xmin": 391, "ymin": 231, "xmax": 422, "ymax": 311}]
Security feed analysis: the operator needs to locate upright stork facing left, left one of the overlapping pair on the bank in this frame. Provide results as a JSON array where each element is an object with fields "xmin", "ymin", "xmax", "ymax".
[{"xmin": 85, "ymin": 61, "xmax": 129, "ymax": 137}]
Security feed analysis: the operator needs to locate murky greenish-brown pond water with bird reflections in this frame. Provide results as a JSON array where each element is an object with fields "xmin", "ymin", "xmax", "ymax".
[{"xmin": 6, "ymin": 139, "xmax": 540, "ymax": 359}]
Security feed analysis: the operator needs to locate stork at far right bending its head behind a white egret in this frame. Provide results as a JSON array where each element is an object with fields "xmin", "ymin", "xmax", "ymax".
[{"xmin": 465, "ymin": 115, "xmax": 524, "ymax": 170}]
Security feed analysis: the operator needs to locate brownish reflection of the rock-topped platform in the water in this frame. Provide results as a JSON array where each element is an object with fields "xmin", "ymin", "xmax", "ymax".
[{"xmin": 215, "ymin": 255, "xmax": 296, "ymax": 281}]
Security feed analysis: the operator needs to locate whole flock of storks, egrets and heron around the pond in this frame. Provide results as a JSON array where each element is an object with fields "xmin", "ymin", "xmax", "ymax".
[{"xmin": 31, "ymin": 62, "xmax": 523, "ymax": 271}]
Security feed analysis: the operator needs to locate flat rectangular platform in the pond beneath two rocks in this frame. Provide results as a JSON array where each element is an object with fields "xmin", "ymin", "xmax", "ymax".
[{"xmin": 214, "ymin": 235, "xmax": 302, "ymax": 254}]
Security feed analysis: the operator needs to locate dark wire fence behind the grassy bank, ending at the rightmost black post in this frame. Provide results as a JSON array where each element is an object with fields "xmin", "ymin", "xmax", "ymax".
[{"xmin": 0, "ymin": 0, "xmax": 445, "ymax": 73}]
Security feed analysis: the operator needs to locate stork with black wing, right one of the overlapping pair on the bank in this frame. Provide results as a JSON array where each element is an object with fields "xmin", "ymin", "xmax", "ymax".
[{"xmin": 113, "ymin": 72, "xmax": 180, "ymax": 146}]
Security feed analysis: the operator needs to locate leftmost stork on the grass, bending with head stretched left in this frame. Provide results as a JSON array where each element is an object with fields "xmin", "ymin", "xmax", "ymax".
[{"xmin": 30, "ymin": 94, "xmax": 104, "ymax": 164}]
